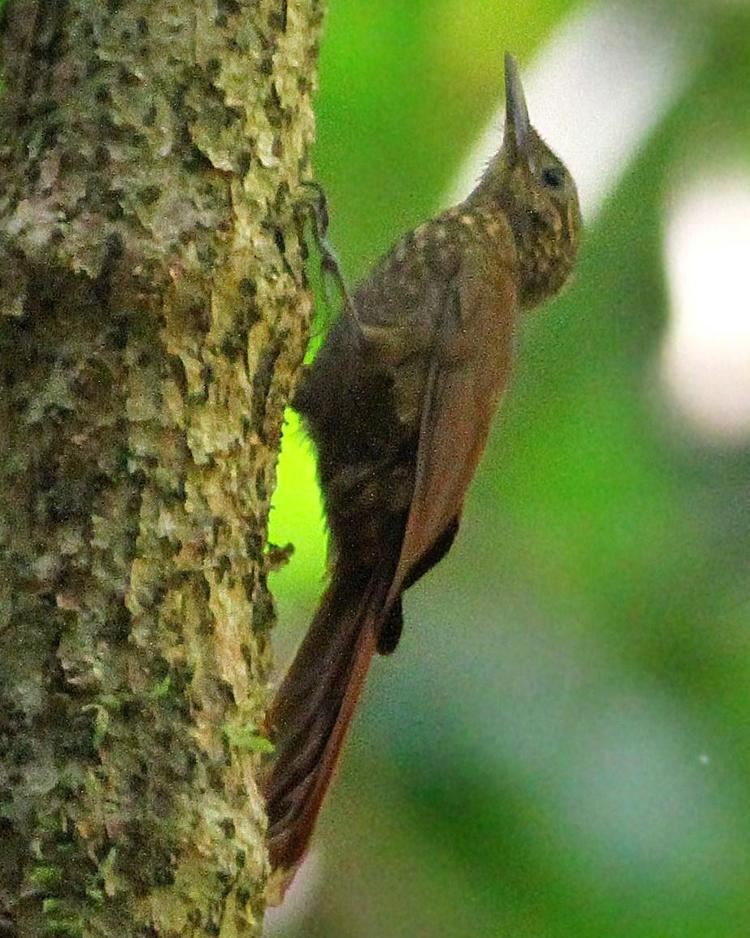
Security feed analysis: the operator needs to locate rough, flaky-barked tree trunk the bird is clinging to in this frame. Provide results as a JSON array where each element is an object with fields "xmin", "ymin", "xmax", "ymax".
[{"xmin": 0, "ymin": 0, "xmax": 321, "ymax": 938}]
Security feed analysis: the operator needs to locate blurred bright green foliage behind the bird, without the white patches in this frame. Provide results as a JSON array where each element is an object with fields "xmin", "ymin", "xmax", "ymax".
[{"xmin": 273, "ymin": 0, "xmax": 750, "ymax": 938}]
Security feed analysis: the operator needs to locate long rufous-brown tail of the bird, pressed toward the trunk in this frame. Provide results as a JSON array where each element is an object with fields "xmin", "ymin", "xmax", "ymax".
[{"xmin": 263, "ymin": 575, "xmax": 387, "ymax": 894}]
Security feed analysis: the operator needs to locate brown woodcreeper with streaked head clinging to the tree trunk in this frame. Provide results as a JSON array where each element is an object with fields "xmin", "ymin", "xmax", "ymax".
[{"xmin": 261, "ymin": 53, "xmax": 582, "ymax": 896}]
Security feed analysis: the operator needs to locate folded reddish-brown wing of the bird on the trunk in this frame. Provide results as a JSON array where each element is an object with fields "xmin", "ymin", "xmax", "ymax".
[{"xmin": 385, "ymin": 252, "xmax": 518, "ymax": 610}]
